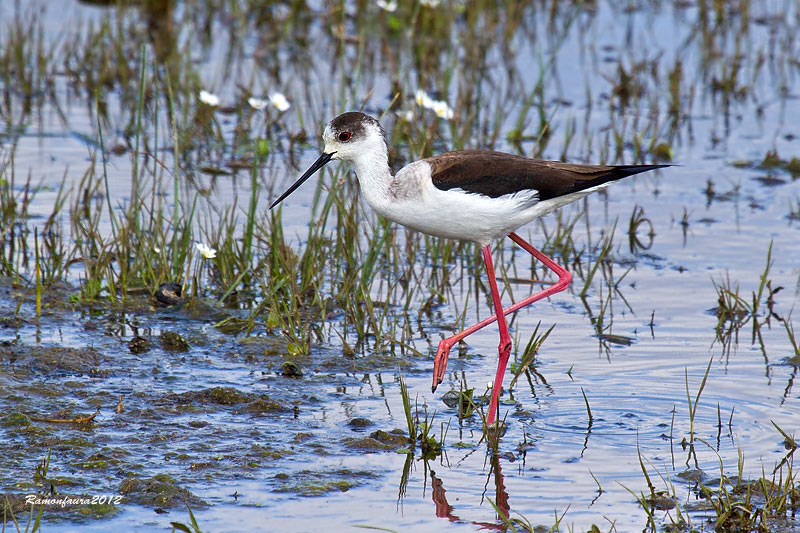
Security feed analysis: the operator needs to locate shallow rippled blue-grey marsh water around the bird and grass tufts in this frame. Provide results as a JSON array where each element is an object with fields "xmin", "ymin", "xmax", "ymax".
[{"xmin": 0, "ymin": 2, "xmax": 800, "ymax": 531}]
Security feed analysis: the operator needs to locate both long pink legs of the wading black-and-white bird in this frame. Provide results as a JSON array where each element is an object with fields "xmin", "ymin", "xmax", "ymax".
[{"xmin": 431, "ymin": 233, "xmax": 572, "ymax": 423}]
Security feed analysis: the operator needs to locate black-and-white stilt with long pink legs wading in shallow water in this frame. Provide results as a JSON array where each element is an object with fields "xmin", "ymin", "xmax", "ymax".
[{"xmin": 270, "ymin": 111, "xmax": 669, "ymax": 425}]
